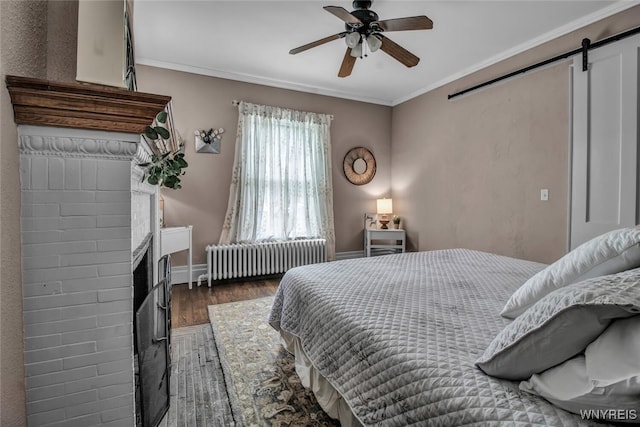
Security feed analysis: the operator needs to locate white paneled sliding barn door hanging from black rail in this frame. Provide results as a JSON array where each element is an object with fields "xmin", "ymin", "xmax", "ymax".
[{"xmin": 570, "ymin": 36, "xmax": 640, "ymax": 249}]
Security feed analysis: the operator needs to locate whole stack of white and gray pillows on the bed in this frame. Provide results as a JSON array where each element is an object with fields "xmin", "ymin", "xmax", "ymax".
[{"xmin": 476, "ymin": 227, "xmax": 640, "ymax": 422}]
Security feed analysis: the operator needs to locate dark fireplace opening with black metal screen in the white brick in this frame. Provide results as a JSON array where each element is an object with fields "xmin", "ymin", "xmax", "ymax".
[{"xmin": 133, "ymin": 236, "xmax": 171, "ymax": 427}]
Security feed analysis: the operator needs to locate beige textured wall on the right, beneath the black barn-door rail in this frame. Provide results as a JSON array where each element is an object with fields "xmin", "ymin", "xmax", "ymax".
[{"xmin": 391, "ymin": 6, "xmax": 640, "ymax": 262}]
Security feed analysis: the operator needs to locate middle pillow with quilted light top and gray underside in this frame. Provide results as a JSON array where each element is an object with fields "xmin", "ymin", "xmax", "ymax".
[{"xmin": 476, "ymin": 269, "xmax": 640, "ymax": 380}]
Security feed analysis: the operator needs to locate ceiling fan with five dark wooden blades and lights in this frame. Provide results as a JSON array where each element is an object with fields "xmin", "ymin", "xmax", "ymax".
[{"xmin": 289, "ymin": 0, "xmax": 433, "ymax": 77}]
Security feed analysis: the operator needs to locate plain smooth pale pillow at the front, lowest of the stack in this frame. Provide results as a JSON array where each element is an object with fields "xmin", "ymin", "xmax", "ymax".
[{"xmin": 520, "ymin": 316, "xmax": 640, "ymax": 423}]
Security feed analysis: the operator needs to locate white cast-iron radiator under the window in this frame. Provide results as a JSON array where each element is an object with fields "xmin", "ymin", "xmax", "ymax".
[{"xmin": 198, "ymin": 239, "xmax": 327, "ymax": 287}]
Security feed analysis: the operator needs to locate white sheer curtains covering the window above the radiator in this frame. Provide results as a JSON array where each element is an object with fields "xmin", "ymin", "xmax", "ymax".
[{"xmin": 220, "ymin": 102, "xmax": 335, "ymax": 260}]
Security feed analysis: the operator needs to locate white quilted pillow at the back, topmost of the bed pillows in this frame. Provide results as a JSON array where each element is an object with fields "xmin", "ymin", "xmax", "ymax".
[{"xmin": 500, "ymin": 227, "xmax": 640, "ymax": 319}]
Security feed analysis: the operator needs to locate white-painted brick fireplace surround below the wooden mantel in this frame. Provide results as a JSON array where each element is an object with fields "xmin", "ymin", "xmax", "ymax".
[{"xmin": 19, "ymin": 126, "xmax": 156, "ymax": 427}]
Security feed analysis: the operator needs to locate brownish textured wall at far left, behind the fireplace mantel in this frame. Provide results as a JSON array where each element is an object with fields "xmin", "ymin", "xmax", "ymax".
[{"xmin": 0, "ymin": 0, "xmax": 77, "ymax": 427}]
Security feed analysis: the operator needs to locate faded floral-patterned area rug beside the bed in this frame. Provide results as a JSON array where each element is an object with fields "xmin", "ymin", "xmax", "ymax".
[{"xmin": 208, "ymin": 297, "xmax": 340, "ymax": 427}]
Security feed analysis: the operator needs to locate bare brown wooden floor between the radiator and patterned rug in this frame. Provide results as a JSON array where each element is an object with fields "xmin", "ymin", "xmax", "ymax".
[{"xmin": 171, "ymin": 278, "xmax": 280, "ymax": 328}]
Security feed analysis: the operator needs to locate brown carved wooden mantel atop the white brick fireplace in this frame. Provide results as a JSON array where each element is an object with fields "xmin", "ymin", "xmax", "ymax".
[{"xmin": 6, "ymin": 76, "xmax": 171, "ymax": 133}]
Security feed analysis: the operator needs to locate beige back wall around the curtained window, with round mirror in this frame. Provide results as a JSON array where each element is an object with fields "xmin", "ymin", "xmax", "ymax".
[{"xmin": 136, "ymin": 65, "xmax": 391, "ymax": 265}]
